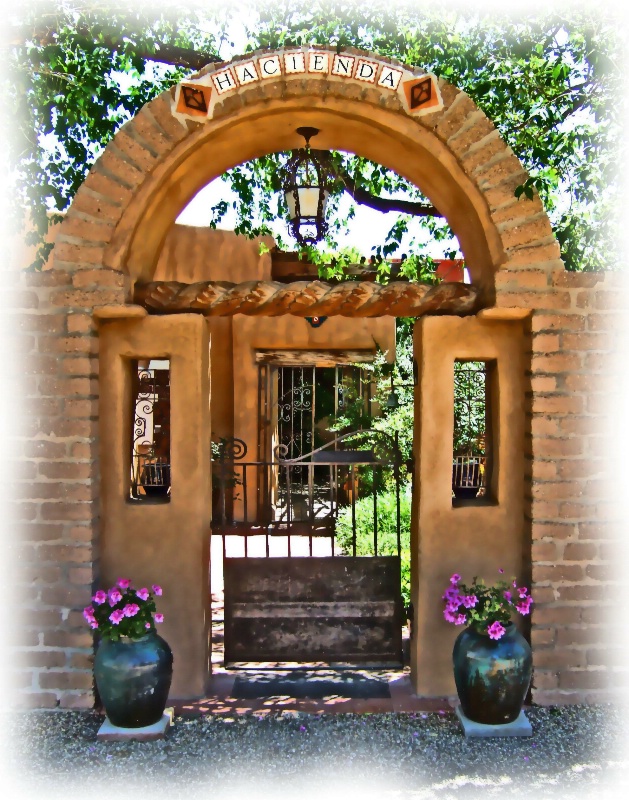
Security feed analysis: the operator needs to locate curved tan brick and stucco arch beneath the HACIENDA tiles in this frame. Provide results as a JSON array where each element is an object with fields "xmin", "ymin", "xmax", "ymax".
[{"xmin": 55, "ymin": 50, "xmax": 562, "ymax": 303}]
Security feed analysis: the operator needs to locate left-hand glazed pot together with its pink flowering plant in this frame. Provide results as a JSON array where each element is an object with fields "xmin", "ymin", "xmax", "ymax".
[{"xmin": 83, "ymin": 578, "xmax": 173, "ymax": 728}]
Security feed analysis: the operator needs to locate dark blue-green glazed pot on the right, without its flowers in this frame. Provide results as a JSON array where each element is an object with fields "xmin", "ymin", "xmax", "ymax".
[{"xmin": 452, "ymin": 623, "xmax": 533, "ymax": 725}]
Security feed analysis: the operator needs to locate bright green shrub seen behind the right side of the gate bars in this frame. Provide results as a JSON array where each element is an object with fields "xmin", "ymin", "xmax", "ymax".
[{"xmin": 336, "ymin": 486, "xmax": 411, "ymax": 607}]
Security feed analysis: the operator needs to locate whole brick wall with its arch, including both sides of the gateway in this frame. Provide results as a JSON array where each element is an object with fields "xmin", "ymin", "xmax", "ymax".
[{"xmin": 9, "ymin": 43, "xmax": 627, "ymax": 708}]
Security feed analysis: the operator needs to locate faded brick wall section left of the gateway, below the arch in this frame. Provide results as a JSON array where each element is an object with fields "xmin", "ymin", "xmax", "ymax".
[{"xmin": 13, "ymin": 265, "xmax": 125, "ymax": 708}]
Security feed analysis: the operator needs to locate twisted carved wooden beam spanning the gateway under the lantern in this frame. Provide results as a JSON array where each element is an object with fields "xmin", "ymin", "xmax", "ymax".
[{"xmin": 134, "ymin": 281, "xmax": 479, "ymax": 317}]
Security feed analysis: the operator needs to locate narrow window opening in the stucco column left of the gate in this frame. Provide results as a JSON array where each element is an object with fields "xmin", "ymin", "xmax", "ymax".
[{"xmin": 130, "ymin": 359, "xmax": 171, "ymax": 503}]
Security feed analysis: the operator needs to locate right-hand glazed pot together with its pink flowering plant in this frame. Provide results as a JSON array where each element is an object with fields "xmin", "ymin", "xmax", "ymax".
[{"xmin": 442, "ymin": 569, "xmax": 533, "ymax": 725}]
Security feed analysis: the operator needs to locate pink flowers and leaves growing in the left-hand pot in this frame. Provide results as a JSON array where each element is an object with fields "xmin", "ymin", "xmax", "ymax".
[{"xmin": 83, "ymin": 578, "xmax": 164, "ymax": 642}]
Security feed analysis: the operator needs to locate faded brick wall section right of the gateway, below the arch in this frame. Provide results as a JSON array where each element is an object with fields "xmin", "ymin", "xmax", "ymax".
[{"xmin": 497, "ymin": 270, "xmax": 629, "ymax": 704}]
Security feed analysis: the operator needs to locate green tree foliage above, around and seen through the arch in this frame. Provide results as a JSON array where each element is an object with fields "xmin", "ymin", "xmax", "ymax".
[{"xmin": 5, "ymin": 0, "xmax": 624, "ymax": 269}]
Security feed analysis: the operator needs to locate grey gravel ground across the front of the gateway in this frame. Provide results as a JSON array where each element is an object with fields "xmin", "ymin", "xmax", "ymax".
[{"xmin": 3, "ymin": 706, "xmax": 629, "ymax": 800}]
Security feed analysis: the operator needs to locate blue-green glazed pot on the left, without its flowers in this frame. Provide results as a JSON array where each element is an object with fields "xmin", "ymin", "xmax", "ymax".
[{"xmin": 94, "ymin": 632, "xmax": 173, "ymax": 728}]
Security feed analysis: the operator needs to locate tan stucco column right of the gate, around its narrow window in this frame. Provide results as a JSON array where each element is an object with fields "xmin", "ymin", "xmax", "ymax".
[{"xmin": 411, "ymin": 317, "xmax": 530, "ymax": 697}]
